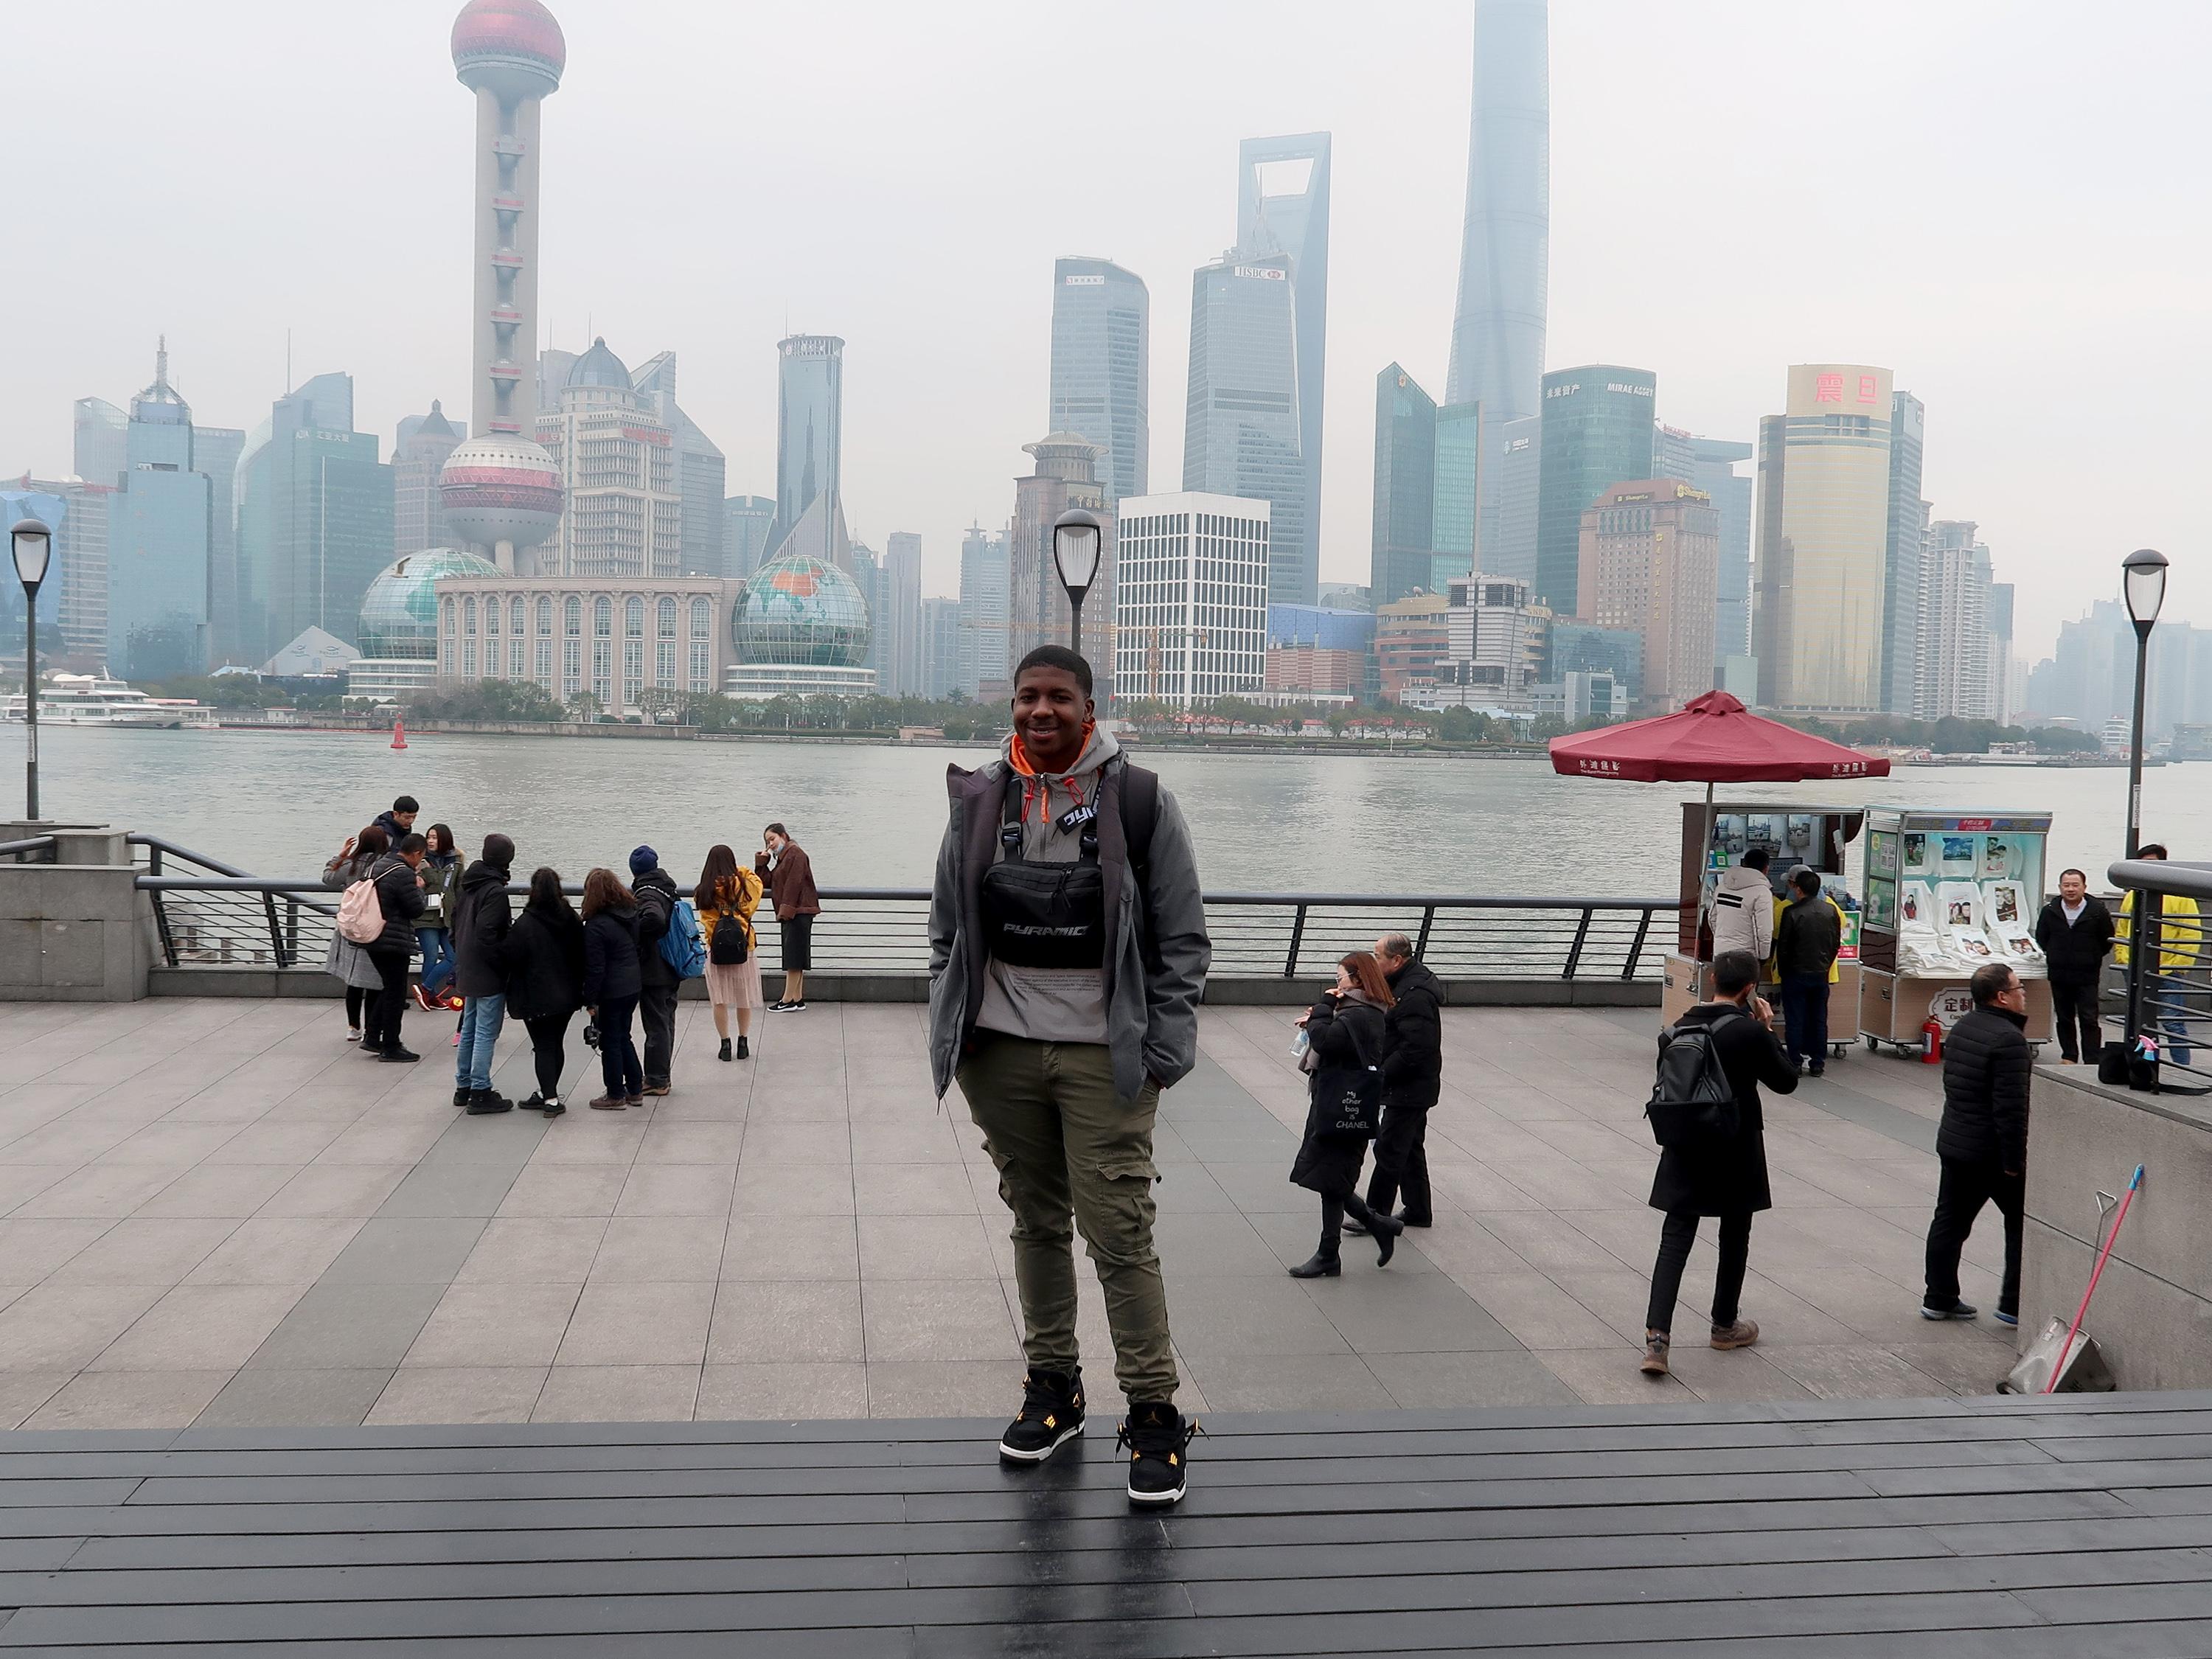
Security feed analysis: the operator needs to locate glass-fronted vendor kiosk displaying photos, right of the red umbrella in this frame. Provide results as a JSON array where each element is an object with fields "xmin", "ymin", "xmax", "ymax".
[{"xmin": 1858, "ymin": 807, "xmax": 2051, "ymax": 1053}]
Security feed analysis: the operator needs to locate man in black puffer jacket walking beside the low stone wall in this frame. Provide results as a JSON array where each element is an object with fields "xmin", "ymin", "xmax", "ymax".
[{"xmin": 1920, "ymin": 962, "xmax": 2035, "ymax": 1325}]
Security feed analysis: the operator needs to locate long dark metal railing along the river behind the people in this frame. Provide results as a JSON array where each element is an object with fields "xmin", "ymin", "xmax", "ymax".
[{"xmin": 131, "ymin": 836, "xmax": 1679, "ymax": 982}]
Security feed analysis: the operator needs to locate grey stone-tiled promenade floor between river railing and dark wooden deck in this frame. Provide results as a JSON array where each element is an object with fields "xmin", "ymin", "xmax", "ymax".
[{"xmin": 0, "ymin": 1000, "xmax": 2011, "ymax": 1429}]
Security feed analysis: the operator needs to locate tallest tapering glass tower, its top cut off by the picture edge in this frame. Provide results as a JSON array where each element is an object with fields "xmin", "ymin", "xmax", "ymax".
[{"xmin": 1444, "ymin": 0, "xmax": 1551, "ymax": 429}]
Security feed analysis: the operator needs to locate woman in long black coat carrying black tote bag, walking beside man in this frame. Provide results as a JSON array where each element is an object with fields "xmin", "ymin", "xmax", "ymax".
[{"xmin": 1290, "ymin": 951, "xmax": 1405, "ymax": 1279}]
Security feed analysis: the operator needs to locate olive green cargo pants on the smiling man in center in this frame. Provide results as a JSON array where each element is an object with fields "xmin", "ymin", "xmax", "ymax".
[{"xmin": 956, "ymin": 1031, "xmax": 1177, "ymax": 1402}]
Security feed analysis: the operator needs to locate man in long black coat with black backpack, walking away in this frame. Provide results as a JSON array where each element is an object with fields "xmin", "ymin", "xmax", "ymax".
[{"xmin": 1644, "ymin": 951, "xmax": 1798, "ymax": 1376}]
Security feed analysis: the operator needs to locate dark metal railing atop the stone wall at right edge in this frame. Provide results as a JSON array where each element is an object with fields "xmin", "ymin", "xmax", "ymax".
[{"xmin": 2106, "ymin": 858, "xmax": 2212, "ymax": 1093}]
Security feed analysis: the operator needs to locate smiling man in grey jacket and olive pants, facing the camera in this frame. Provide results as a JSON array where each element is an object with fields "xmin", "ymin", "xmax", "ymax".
[{"xmin": 929, "ymin": 646, "xmax": 1212, "ymax": 1504}]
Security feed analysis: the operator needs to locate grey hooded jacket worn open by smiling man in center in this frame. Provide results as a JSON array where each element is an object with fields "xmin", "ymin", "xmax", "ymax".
[{"xmin": 929, "ymin": 730, "xmax": 1212, "ymax": 1099}]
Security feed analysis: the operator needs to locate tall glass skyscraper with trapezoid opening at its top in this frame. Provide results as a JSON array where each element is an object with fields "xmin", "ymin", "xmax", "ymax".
[{"xmin": 1230, "ymin": 133, "xmax": 1329, "ymax": 604}]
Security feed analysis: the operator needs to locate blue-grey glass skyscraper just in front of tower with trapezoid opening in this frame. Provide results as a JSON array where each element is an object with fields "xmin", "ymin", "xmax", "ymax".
[{"xmin": 1183, "ymin": 252, "xmax": 1318, "ymax": 604}]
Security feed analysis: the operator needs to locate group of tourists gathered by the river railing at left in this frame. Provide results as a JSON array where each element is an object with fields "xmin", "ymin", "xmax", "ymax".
[{"xmin": 323, "ymin": 794, "xmax": 821, "ymax": 1117}]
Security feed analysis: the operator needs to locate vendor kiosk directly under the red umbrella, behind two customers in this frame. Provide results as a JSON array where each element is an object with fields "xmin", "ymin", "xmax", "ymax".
[{"xmin": 1659, "ymin": 801, "xmax": 1865, "ymax": 1053}]
